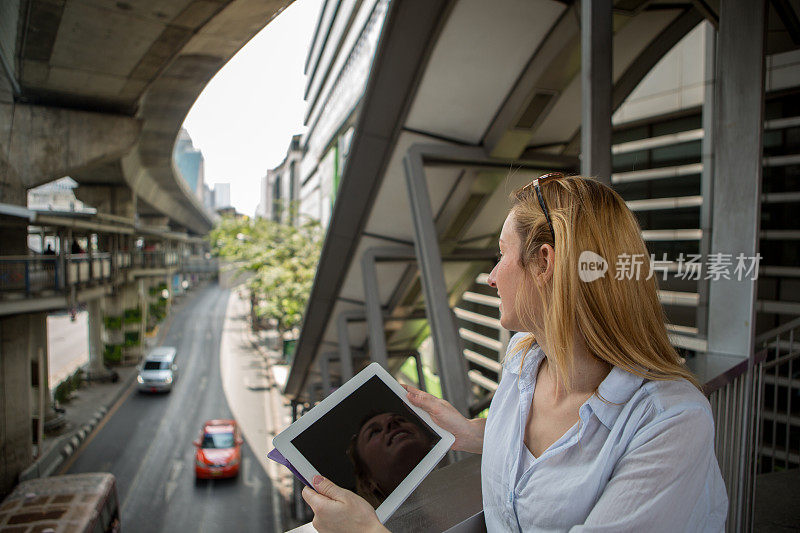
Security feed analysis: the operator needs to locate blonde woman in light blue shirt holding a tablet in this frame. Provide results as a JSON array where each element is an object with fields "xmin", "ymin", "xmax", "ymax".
[{"xmin": 303, "ymin": 173, "xmax": 728, "ymax": 532}]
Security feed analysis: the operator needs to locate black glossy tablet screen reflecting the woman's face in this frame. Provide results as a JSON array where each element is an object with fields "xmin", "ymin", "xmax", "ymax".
[{"xmin": 291, "ymin": 376, "xmax": 441, "ymax": 508}]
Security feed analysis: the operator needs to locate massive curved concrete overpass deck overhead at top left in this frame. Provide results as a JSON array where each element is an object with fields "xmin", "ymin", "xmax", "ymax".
[{"xmin": 0, "ymin": 0, "xmax": 290, "ymax": 234}]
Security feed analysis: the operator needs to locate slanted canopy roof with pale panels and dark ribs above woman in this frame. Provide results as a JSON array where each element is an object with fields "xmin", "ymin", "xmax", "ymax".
[{"xmin": 286, "ymin": 0, "xmax": 732, "ymax": 399}]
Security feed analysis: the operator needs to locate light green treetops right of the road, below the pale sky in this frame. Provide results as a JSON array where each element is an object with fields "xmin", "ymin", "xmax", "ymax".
[{"xmin": 210, "ymin": 213, "xmax": 323, "ymax": 332}]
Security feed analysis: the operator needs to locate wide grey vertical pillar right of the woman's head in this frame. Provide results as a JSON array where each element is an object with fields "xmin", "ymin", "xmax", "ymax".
[{"xmin": 708, "ymin": 0, "xmax": 766, "ymax": 357}]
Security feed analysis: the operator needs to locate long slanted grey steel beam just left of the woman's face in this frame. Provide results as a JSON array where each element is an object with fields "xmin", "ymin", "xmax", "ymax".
[{"xmin": 403, "ymin": 145, "xmax": 472, "ymax": 416}]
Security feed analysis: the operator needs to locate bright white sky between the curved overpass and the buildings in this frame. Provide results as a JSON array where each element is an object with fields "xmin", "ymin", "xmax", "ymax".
[{"xmin": 184, "ymin": 0, "xmax": 322, "ymax": 216}]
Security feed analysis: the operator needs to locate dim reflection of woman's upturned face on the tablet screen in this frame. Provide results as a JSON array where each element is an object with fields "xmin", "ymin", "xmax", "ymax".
[{"xmin": 348, "ymin": 412, "xmax": 433, "ymax": 507}]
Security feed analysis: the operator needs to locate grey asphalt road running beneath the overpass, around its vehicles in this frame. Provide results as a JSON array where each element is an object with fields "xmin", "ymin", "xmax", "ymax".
[{"xmin": 61, "ymin": 285, "xmax": 276, "ymax": 533}]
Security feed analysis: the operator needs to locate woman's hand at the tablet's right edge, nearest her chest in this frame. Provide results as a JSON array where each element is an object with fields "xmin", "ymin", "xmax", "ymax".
[{"xmin": 403, "ymin": 385, "xmax": 486, "ymax": 453}]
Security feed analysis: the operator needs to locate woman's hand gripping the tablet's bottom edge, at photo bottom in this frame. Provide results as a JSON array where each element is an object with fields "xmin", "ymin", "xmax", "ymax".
[{"xmin": 303, "ymin": 476, "xmax": 389, "ymax": 533}]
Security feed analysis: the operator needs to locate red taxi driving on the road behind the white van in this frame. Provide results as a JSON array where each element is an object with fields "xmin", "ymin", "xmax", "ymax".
[{"xmin": 194, "ymin": 420, "xmax": 244, "ymax": 479}]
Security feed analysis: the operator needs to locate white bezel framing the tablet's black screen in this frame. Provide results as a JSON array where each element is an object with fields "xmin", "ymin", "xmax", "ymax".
[{"xmin": 272, "ymin": 363, "xmax": 455, "ymax": 523}]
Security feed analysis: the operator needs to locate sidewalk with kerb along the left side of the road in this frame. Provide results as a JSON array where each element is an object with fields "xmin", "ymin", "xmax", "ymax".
[{"xmin": 19, "ymin": 290, "xmax": 184, "ymax": 481}]
